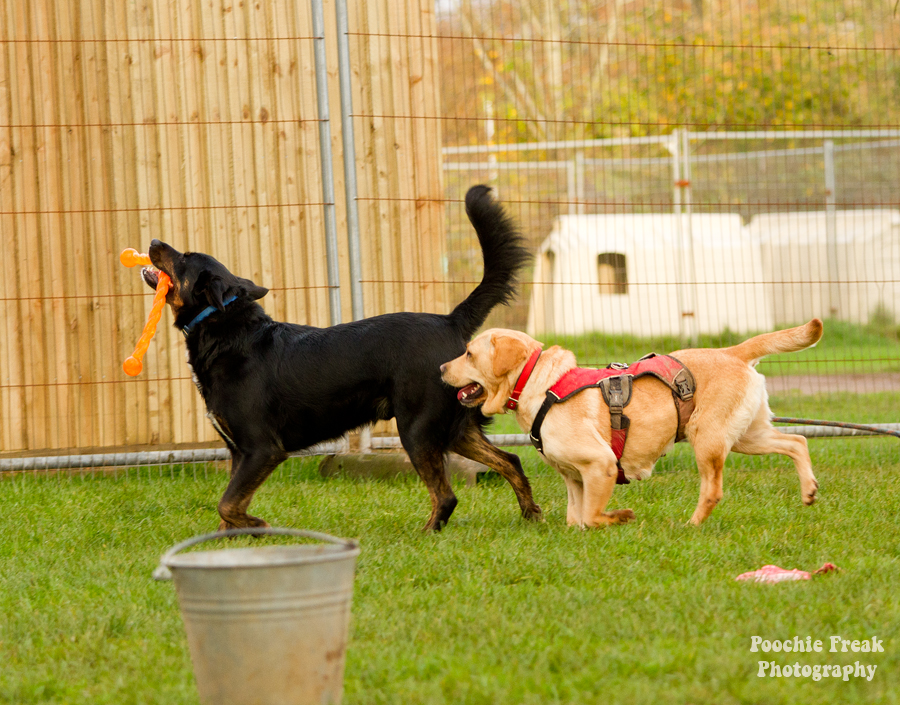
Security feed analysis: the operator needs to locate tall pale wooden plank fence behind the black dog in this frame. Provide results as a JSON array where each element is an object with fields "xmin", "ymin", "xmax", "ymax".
[{"xmin": 0, "ymin": 0, "xmax": 447, "ymax": 454}]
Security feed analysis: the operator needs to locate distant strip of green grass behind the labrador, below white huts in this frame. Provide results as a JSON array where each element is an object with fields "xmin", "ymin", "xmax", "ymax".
[{"xmin": 541, "ymin": 320, "xmax": 900, "ymax": 376}]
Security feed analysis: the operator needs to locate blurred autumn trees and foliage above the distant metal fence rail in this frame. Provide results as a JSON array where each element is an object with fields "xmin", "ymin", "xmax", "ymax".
[{"xmin": 439, "ymin": 0, "xmax": 900, "ymax": 144}]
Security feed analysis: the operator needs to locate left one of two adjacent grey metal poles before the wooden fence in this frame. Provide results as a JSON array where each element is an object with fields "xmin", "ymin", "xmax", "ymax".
[{"xmin": 312, "ymin": 0, "xmax": 341, "ymax": 326}]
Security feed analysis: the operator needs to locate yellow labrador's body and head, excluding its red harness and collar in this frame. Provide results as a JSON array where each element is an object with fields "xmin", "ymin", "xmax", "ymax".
[{"xmin": 441, "ymin": 319, "xmax": 822, "ymax": 527}]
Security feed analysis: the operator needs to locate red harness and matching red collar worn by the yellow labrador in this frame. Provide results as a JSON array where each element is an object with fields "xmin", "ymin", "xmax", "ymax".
[{"xmin": 524, "ymin": 353, "xmax": 696, "ymax": 485}]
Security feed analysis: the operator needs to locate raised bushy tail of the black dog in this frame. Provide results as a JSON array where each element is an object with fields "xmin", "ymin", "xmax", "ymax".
[{"xmin": 450, "ymin": 186, "xmax": 531, "ymax": 339}]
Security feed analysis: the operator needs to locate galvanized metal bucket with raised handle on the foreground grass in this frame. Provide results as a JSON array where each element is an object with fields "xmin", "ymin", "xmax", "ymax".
[{"xmin": 153, "ymin": 528, "xmax": 359, "ymax": 705}]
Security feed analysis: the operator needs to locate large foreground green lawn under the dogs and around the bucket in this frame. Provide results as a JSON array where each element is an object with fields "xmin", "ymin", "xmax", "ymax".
[{"xmin": 0, "ymin": 432, "xmax": 900, "ymax": 705}]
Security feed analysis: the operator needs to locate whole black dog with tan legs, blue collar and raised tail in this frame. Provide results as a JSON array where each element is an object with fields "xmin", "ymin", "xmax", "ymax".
[{"xmin": 143, "ymin": 186, "xmax": 541, "ymax": 530}]
